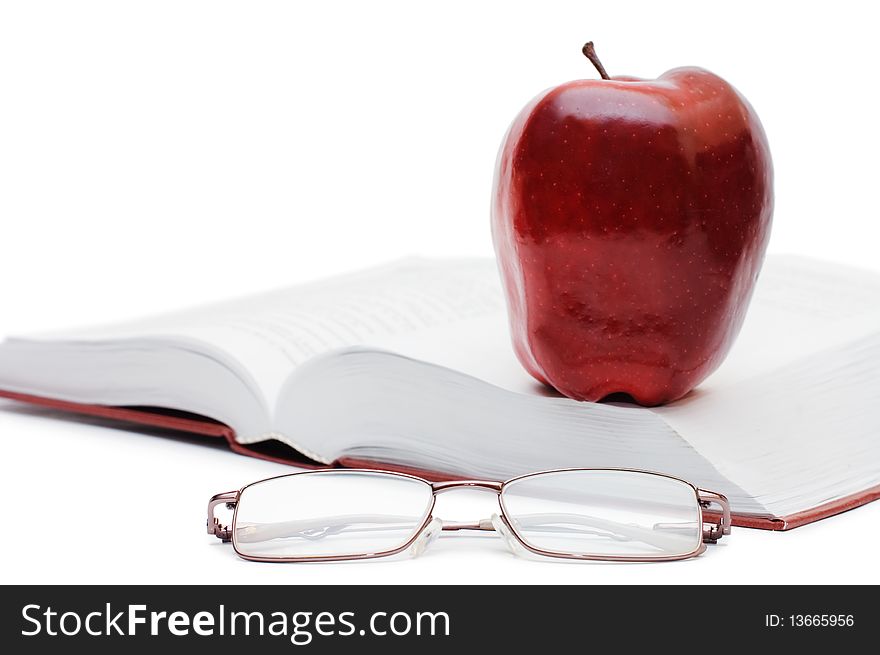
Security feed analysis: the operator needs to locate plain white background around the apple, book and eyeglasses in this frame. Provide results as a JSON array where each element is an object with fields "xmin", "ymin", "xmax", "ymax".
[{"xmin": 0, "ymin": 0, "xmax": 880, "ymax": 584}]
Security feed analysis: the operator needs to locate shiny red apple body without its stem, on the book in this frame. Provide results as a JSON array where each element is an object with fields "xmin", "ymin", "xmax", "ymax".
[{"xmin": 492, "ymin": 68, "xmax": 773, "ymax": 405}]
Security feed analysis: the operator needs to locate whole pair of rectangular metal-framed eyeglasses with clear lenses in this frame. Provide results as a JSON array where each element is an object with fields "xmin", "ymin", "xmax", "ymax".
[{"xmin": 208, "ymin": 469, "xmax": 730, "ymax": 562}]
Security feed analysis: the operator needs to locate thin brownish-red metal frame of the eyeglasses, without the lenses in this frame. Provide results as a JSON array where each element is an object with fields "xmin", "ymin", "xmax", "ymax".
[{"xmin": 207, "ymin": 467, "xmax": 731, "ymax": 563}]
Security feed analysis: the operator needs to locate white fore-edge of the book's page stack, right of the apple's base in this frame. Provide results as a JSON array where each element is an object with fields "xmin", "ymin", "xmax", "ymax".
[{"xmin": 659, "ymin": 333, "xmax": 880, "ymax": 516}]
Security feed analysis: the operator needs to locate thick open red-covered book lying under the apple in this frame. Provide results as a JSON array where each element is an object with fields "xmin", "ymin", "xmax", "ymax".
[{"xmin": 0, "ymin": 257, "xmax": 880, "ymax": 529}]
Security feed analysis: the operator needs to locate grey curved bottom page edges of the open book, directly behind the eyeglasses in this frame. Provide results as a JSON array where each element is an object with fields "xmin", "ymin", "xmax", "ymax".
[{"xmin": 277, "ymin": 348, "xmax": 762, "ymax": 515}]
